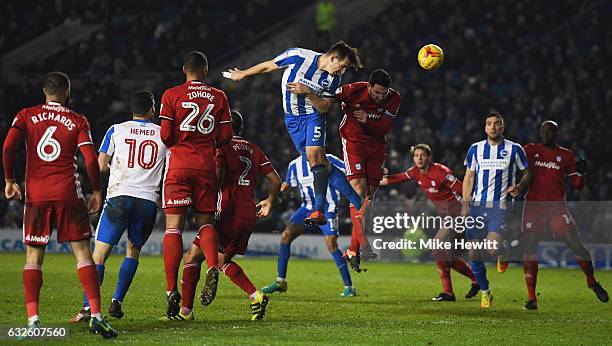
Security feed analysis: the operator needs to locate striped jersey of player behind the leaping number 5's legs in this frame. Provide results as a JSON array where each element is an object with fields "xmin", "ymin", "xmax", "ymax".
[{"xmin": 285, "ymin": 154, "xmax": 344, "ymax": 213}]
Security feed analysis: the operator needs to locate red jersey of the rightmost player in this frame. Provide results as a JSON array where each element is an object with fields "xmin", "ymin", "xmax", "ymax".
[{"xmin": 524, "ymin": 143, "xmax": 584, "ymax": 201}]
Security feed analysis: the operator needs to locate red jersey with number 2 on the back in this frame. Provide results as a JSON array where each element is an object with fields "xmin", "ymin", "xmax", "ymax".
[{"xmin": 217, "ymin": 136, "xmax": 274, "ymax": 217}]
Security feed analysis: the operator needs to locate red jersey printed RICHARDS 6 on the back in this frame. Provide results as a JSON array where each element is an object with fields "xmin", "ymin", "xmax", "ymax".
[{"xmin": 12, "ymin": 102, "xmax": 93, "ymax": 202}]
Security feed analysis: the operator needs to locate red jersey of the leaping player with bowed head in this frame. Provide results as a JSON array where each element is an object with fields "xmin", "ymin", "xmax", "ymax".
[{"xmin": 334, "ymin": 82, "xmax": 401, "ymax": 144}]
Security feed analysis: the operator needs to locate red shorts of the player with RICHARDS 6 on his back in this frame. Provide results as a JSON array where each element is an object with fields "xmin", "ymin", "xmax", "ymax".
[{"xmin": 23, "ymin": 199, "xmax": 92, "ymax": 245}]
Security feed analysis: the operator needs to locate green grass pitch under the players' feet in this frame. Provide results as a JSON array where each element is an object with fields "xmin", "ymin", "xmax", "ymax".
[{"xmin": 0, "ymin": 254, "xmax": 612, "ymax": 345}]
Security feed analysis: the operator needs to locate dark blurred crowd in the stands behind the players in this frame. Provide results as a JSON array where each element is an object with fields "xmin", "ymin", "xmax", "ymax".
[{"xmin": 0, "ymin": 0, "xmax": 612, "ymax": 238}]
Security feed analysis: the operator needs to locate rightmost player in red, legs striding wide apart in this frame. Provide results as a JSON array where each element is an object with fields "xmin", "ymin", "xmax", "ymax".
[{"xmin": 522, "ymin": 120, "xmax": 608, "ymax": 310}]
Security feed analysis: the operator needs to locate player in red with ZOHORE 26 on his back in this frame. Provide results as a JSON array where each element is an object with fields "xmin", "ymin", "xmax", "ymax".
[{"xmin": 159, "ymin": 51, "xmax": 232, "ymax": 317}]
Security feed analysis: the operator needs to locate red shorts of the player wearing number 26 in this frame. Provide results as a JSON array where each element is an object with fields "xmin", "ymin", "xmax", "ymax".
[{"xmin": 162, "ymin": 168, "xmax": 217, "ymax": 214}]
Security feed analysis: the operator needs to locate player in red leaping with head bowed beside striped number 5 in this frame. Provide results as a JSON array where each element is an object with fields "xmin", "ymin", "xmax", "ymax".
[{"xmin": 287, "ymin": 69, "xmax": 401, "ymax": 272}]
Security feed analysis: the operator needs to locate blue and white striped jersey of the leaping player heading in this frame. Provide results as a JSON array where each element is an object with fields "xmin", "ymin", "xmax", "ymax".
[{"xmin": 274, "ymin": 48, "xmax": 341, "ymax": 116}]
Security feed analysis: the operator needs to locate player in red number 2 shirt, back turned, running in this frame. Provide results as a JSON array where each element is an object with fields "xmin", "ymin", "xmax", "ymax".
[{"xmin": 167, "ymin": 111, "xmax": 281, "ymax": 320}]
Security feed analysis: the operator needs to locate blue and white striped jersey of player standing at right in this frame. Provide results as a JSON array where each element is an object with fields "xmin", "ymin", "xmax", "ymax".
[{"xmin": 464, "ymin": 138, "xmax": 528, "ymax": 209}]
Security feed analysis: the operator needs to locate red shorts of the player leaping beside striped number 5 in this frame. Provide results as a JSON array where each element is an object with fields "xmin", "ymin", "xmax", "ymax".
[{"xmin": 342, "ymin": 138, "xmax": 387, "ymax": 186}]
